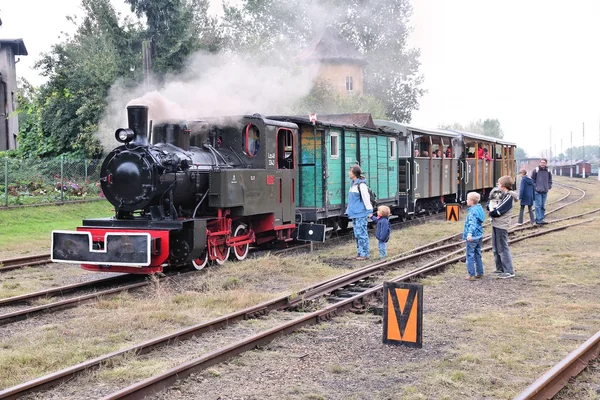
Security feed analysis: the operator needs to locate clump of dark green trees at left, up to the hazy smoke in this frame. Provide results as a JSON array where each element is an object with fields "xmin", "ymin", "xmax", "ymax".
[{"xmin": 19, "ymin": 0, "xmax": 220, "ymax": 157}]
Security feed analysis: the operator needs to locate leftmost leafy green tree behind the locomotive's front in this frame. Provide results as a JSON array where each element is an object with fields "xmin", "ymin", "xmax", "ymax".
[{"xmin": 25, "ymin": 0, "xmax": 141, "ymax": 156}]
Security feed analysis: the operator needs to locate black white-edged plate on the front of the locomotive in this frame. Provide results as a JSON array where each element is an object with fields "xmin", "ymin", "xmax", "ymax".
[{"xmin": 51, "ymin": 231, "xmax": 152, "ymax": 267}]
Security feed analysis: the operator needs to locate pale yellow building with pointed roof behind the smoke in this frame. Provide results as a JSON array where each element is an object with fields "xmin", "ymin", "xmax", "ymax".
[{"xmin": 296, "ymin": 26, "xmax": 368, "ymax": 94}]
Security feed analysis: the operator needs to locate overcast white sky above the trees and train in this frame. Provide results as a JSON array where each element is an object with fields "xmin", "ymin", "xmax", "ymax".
[{"xmin": 0, "ymin": 0, "xmax": 600, "ymax": 156}]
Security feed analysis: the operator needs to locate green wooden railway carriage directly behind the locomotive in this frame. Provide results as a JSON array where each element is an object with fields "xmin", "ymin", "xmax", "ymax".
[{"xmin": 270, "ymin": 114, "xmax": 398, "ymax": 229}]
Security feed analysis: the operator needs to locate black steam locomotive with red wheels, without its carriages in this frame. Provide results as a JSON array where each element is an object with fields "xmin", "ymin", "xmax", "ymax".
[{"xmin": 52, "ymin": 106, "xmax": 297, "ymax": 274}]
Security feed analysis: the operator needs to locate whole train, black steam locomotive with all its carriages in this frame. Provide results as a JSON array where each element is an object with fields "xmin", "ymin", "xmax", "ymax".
[{"xmin": 52, "ymin": 106, "xmax": 516, "ymax": 274}]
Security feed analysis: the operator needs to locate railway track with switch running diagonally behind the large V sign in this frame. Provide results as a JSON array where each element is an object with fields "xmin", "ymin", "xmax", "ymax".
[{"xmin": 0, "ymin": 202, "xmax": 600, "ymax": 398}]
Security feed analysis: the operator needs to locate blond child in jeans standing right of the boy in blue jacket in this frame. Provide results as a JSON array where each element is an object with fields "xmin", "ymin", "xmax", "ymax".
[{"xmin": 488, "ymin": 175, "xmax": 517, "ymax": 279}]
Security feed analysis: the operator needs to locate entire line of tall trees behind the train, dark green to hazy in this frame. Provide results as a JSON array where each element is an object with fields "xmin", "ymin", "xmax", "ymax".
[{"xmin": 17, "ymin": 0, "xmax": 424, "ymax": 156}]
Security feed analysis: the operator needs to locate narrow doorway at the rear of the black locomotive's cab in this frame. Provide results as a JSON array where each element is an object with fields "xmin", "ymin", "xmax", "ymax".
[{"xmin": 276, "ymin": 128, "xmax": 296, "ymax": 224}]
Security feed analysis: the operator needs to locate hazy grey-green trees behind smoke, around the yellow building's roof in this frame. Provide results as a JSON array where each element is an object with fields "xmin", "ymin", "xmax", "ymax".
[{"xmin": 224, "ymin": 0, "xmax": 424, "ymax": 122}]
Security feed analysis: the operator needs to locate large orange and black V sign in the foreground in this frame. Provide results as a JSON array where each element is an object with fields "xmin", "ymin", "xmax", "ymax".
[{"xmin": 383, "ymin": 282, "xmax": 423, "ymax": 348}]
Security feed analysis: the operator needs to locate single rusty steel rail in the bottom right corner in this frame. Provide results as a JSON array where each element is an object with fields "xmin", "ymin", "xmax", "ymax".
[{"xmin": 515, "ymin": 331, "xmax": 600, "ymax": 400}]
